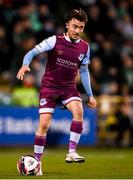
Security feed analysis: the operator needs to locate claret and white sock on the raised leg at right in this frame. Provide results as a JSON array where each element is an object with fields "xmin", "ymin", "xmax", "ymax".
[{"xmin": 69, "ymin": 120, "xmax": 83, "ymax": 152}]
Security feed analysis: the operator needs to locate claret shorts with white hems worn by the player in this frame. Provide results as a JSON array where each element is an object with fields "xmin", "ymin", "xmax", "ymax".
[{"xmin": 39, "ymin": 87, "xmax": 81, "ymax": 114}]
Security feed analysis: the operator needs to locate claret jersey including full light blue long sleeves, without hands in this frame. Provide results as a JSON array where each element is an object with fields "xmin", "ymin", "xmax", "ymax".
[{"xmin": 23, "ymin": 34, "xmax": 92, "ymax": 96}]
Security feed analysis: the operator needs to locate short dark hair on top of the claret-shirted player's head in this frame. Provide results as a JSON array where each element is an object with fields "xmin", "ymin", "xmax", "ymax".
[{"xmin": 66, "ymin": 9, "xmax": 88, "ymax": 23}]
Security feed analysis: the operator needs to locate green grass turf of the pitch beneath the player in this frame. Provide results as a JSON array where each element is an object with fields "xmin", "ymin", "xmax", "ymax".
[{"xmin": 0, "ymin": 148, "xmax": 133, "ymax": 179}]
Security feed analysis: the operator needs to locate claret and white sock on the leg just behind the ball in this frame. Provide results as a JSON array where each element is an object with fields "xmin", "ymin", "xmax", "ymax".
[{"xmin": 34, "ymin": 135, "xmax": 46, "ymax": 161}]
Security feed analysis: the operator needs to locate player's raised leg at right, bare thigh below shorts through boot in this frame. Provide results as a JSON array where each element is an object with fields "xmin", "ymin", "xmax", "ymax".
[{"xmin": 66, "ymin": 100, "xmax": 84, "ymax": 163}]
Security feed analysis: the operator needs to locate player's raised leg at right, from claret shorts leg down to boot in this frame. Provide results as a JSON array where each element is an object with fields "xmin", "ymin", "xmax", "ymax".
[{"xmin": 62, "ymin": 86, "xmax": 84, "ymax": 162}]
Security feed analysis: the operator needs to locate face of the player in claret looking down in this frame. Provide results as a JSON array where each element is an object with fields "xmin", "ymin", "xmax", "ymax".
[{"xmin": 66, "ymin": 18, "xmax": 85, "ymax": 40}]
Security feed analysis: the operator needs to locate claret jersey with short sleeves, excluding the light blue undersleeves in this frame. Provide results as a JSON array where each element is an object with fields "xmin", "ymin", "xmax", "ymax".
[{"xmin": 35, "ymin": 36, "xmax": 89, "ymax": 87}]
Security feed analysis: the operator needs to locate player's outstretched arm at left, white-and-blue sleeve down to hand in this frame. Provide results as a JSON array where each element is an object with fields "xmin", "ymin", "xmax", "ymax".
[{"xmin": 17, "ymin": 36, "xmax": 56, "ymax": 80}]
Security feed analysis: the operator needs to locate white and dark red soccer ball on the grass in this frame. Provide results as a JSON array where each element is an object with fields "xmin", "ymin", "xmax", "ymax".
[{"xmin": 17, "ymin": 155, "xmax": 40, "ymax": 175}]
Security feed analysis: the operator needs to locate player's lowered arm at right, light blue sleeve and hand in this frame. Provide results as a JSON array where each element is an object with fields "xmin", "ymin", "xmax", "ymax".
[{"xmin": 79, "ymin": 48, "xmax": 97, "ymax": 108}]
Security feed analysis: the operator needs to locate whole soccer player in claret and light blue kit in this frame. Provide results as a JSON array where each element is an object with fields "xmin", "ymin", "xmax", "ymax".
[{"xmin": 17, "ymin": 9, "xmax": 96, "ymax": 175}]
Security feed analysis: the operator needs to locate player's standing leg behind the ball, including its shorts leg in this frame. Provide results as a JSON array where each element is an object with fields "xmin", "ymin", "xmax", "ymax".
[{"xmin": 34, "ymin": 88, "xmax": 56, "ymax": 175}]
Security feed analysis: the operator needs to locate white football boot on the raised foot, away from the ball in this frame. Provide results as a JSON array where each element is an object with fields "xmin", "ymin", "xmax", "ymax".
[{"xmin": 65, "ymin": 151, "xmax": 85, "ymax": 163}]
